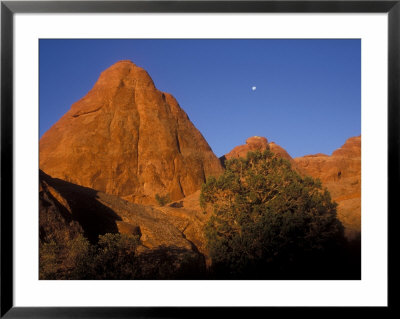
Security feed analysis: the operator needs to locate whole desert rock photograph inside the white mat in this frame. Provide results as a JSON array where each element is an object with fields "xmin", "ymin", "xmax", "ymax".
[{"xmin": 39, "ymin": 38, "xmax": 362, "ymax": 280}]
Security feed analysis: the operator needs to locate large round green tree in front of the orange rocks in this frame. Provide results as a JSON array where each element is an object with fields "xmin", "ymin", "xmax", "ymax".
[{"xmin": 200, "ymin": 150, "xmax": 344, "ymax": 278}]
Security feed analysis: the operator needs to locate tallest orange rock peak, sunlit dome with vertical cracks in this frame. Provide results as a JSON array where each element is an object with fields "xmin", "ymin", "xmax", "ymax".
[{"xmin": 40, "ymin": 61, "xmax": 223, "ymax": 203}]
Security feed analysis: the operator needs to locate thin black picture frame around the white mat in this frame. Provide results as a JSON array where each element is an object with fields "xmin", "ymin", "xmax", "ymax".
[{"xmin": 0, "ymin": 0, "xmax": 400, "ymax": 318}]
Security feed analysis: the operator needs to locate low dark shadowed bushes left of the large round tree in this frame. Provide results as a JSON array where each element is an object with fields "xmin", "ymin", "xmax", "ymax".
[{"xmin": 39, "ymin": 233, "xmax": 205, "ymax": 280}]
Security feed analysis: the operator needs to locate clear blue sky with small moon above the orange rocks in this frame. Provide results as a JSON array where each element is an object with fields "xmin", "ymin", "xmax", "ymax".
[{"xmin": 39, "ymin": 39, "xmax": 361, "ymax": 157}]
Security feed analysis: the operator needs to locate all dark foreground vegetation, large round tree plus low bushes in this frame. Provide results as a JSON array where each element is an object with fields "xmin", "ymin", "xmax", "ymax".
[{"xmin": 39, "ymin": 150, "xmax": 361, "ymax": 280}]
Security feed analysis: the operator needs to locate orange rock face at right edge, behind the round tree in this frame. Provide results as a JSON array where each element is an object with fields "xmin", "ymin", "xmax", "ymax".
[{"xmin": 294, "ymin": 136, "xmax": 361, "ymax": 238}]
